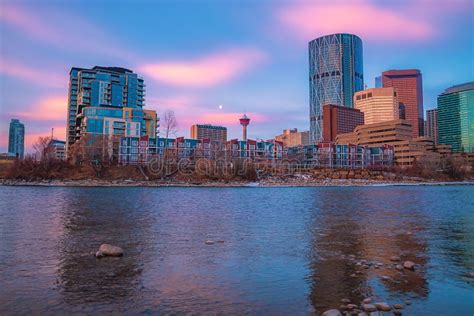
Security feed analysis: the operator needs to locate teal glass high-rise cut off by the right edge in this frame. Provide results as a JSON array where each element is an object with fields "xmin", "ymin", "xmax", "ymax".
[{"xmin": 438, "ymin": 82, "xmax": 474, "ymax": 152}]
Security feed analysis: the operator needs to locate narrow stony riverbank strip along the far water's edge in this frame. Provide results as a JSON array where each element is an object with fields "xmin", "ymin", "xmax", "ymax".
[{"xmin": 0, "ymin": 176, "xmax": 474, "ymax": 188}]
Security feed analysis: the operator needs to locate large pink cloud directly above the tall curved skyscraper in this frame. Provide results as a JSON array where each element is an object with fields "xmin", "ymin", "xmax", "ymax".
[{"xmin": 277, "ymin": 0, "xmax": 434, "ymax": 41}]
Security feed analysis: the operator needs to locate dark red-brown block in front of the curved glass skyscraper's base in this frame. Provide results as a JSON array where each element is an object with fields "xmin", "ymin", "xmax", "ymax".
[{"xmin": 323, "ymin": 104, "xmax": 364, "ymax": 142}]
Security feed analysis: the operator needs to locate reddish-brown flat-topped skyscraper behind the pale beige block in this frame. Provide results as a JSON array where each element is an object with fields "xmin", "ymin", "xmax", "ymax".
[{"xmin": 382, "ymin": 69, "xmax": 424, "ymax": 137}]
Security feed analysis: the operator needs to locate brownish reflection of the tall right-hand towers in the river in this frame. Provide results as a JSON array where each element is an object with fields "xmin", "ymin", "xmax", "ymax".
[{"xmin": 310, "ymin": 188, "xmax": 434, "ymax": 311}]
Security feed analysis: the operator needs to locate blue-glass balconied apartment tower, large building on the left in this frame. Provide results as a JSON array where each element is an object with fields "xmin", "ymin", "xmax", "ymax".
[{"xmin": 66, "ymin": 66, "xmax": 157, "ymax": 152}]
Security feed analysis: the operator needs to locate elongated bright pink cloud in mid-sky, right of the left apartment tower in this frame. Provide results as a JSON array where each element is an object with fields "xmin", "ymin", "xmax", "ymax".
[{"xmin": 139, "ymin": 49, "xmax": 266, "ymax": 87}]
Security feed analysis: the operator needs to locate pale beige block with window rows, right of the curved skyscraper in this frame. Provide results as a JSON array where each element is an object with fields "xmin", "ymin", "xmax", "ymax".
[{"xmin": 354, "ymin": 88, "xmax": 400, "ymax": 124}]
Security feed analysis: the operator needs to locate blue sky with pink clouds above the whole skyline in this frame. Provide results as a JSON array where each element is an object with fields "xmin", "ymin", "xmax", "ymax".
[{"xmin": 0, "ymin": 0, "xmax": 474, "ymax": 152}]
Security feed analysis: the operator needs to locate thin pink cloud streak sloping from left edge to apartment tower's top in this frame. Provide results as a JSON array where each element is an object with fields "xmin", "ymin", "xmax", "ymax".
[{"xmin": 0, "ymin": 56, "xmax": 68, "ymax": 89}]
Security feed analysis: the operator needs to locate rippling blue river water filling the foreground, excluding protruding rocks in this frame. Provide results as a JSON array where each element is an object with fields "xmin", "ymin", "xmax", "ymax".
[{"xmin": 0, "ymin": 186, "xmax": 474, "ymax": 315}]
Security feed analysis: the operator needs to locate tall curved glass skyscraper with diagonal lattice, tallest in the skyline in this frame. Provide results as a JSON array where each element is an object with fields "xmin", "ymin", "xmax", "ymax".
[{"xmin": 308, "ymin": 33, "xmax": 364, "ymax": 143}]
